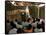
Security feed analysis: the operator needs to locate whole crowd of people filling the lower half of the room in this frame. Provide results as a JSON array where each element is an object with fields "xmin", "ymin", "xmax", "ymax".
[{"xmin": 6, "ymin": 17, "xmax": 45, "ymax": 34}]
